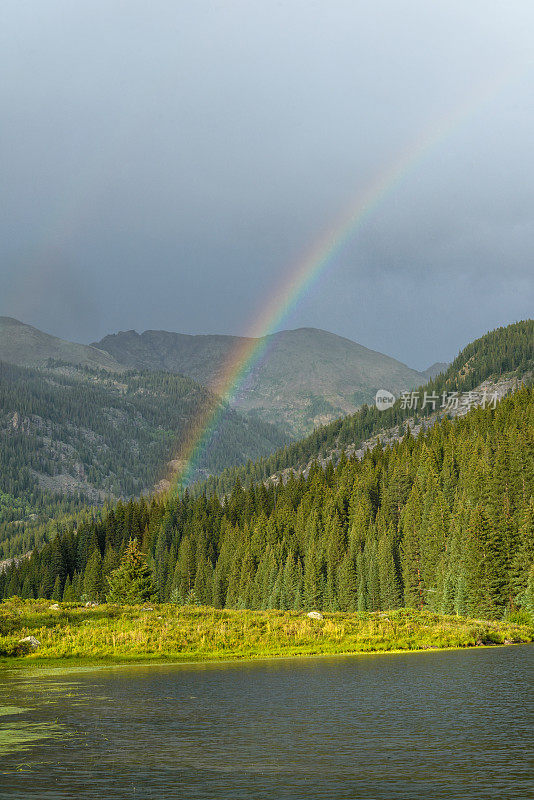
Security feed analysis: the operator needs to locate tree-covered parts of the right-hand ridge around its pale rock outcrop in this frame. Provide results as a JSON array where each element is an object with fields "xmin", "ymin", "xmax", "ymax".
[{"xmin": 199, "ymin": 320, "xmax": 534, "ymax": 496}]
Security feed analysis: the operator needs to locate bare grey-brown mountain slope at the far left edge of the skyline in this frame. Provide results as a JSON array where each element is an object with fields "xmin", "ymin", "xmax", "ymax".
[{"xmin": 0, "ymin": 317, "xmax": 124, "ymax": 372}]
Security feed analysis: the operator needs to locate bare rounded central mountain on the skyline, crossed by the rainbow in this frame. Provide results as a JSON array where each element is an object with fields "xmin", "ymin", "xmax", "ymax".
[{"xmin": 94, "ymin": 328, "xmax": 425, "ymax": 436}]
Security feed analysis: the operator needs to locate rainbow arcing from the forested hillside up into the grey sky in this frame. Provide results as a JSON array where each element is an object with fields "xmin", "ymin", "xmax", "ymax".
[{"xmin": 165, "ymin": 71, "xmax": 509, "ymax": 490}]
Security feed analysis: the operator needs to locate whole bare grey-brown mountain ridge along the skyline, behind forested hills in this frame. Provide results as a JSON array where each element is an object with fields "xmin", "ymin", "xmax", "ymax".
[{"xmin": 0, "ymin": 317, "xmax": 430, "ymax": 438}]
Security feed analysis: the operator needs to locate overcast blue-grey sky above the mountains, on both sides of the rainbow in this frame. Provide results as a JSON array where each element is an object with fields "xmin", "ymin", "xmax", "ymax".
[{"xmin": 0, "ymin": 0, "xmax": 534, "ymax": 368}]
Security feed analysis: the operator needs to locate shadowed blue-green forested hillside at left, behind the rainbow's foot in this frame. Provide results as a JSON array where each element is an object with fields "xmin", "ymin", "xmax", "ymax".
[{"xmin": 0, "ymin": 359, "xmax": 285, "ymax": 558}]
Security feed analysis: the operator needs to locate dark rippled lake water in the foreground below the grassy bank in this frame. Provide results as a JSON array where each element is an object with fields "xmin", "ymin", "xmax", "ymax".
[{"xmin": 0, "ymin": 645, "xmax": 534, "ymax": 800}]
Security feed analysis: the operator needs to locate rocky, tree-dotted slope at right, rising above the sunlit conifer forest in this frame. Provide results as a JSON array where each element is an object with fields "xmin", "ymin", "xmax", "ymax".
[{"xmin": 198, "ymin": 320, "xmax": 534, "ymax": 495}]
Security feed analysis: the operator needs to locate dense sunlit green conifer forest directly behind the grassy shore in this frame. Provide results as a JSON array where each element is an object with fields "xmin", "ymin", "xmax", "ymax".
[{"xmin": 0, "ymin": 384, "xmax": 534, "ymax": 618}]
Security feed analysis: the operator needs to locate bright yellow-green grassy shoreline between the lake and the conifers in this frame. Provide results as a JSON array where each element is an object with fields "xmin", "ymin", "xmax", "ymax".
[{"xmin": 0, "ymin": 598, "xmax": 534, "ymax": 671}]
